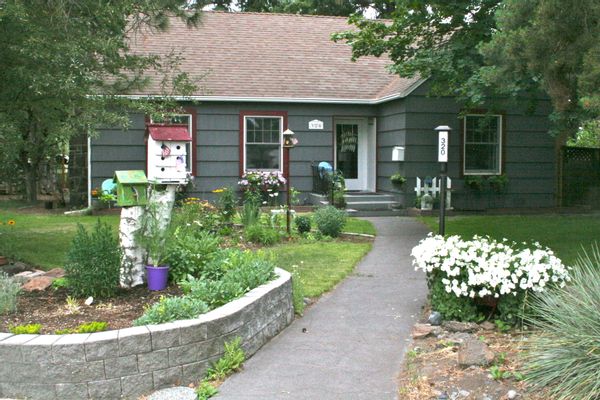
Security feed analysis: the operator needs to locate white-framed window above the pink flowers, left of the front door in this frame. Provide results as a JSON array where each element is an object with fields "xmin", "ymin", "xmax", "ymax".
[{"xmin": 243, "ymin": 116, "xmax": 284, "ymax": 171}]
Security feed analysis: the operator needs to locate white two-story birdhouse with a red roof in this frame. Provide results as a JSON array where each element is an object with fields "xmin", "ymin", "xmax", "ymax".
[{"xmin": 148, "ymin": 124, "xmax": 192, "ymax": 184}]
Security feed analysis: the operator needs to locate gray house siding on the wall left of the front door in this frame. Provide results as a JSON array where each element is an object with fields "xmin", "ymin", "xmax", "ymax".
[{"xmin": 92, "ymin": 102, "xmax": 376, "ymax": 205}]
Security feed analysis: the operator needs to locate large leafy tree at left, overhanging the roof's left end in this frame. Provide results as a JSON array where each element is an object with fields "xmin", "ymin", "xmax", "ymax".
[{"xmin": 0, "ymin": 0, "xmax": 202, "ymax": 201}]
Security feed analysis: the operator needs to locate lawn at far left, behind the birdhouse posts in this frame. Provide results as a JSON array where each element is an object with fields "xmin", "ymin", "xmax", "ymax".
[{"xmin": 0, "ymin": 204, "xmax": 119, "ymax": 270}]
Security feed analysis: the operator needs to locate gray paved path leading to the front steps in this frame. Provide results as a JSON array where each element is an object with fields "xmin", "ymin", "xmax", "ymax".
[{"xmin": 214, "ymin": 217, "xmax": 427, "ymax": 400}]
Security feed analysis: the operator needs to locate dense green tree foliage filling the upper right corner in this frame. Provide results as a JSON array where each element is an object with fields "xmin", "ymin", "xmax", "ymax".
[{"xmin": 480, "ymin": 0, "xmax": 600, "ymax": 139}]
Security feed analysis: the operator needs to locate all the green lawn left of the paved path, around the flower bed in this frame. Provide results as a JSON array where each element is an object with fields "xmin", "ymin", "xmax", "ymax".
[{"xmin": 0, "ymin": 203, "xmax": 375, "ymax": 297}]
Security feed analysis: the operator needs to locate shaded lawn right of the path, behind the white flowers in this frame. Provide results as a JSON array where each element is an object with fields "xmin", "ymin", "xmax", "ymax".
[{"xmin": 422, "ymin": 215, "xmax": 600, "ymax": 265}]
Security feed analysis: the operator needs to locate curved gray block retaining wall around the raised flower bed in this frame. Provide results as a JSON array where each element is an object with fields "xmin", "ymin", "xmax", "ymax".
[{"xmin": 0, "ymin": 269, "xmax": 294, "ymax": 400}]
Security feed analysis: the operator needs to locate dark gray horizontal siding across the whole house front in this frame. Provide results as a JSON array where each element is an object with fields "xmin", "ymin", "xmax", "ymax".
[{"xmin": 91, "ymin": 85, "xmax": 556, "ymax": 209}]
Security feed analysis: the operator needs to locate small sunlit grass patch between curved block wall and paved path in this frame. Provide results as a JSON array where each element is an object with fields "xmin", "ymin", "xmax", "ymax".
[{"xmin": 273, "ymin": 241, "xmax": 371, "ymax": 297}]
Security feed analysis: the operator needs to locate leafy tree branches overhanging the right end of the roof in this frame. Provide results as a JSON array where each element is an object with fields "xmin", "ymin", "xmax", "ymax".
[{"xmin": 334, "ymin": 0, "xmax": 500, "ymax": 103}]
